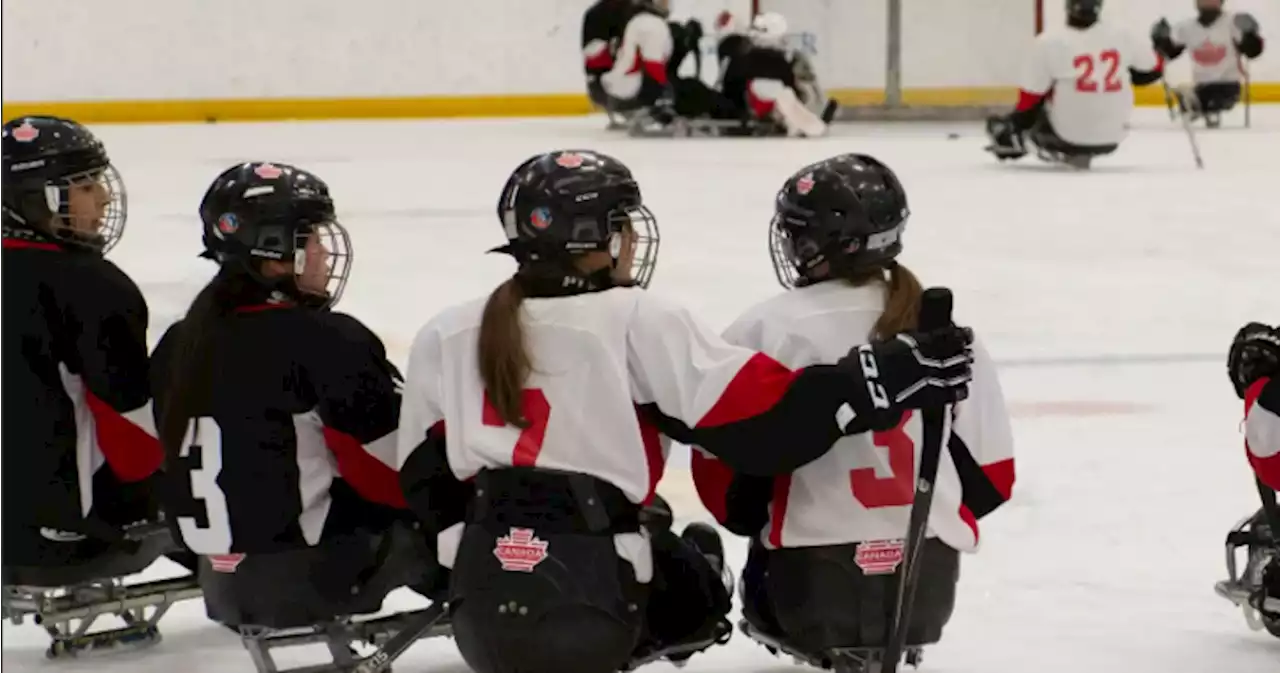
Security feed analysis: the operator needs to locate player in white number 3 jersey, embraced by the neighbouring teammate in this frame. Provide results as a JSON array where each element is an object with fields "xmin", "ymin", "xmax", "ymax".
[{"xmin": 692, "ymin": 155, "xmax": 1014, "ymax": 664}]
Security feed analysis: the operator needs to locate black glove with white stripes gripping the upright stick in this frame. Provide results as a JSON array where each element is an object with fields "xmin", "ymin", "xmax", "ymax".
[{"xmin": 836, "ymin": 325, "xmax": 973, "ymax": 430}]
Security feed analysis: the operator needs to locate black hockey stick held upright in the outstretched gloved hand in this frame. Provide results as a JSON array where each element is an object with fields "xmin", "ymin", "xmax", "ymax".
[{"xmin": 881, "ymin": 288, "xmax": 952, "ymax": 673}]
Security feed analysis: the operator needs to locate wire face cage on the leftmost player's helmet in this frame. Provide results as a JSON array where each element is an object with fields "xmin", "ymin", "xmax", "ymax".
[{"xmin": 36, "ymin": 164, "xmax": 128, "ymax": 255}]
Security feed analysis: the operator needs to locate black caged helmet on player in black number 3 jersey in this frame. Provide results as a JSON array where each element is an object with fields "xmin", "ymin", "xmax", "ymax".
[{"xmin": 200, "ymin": 161, "xmax": 352, "ymax": 306}]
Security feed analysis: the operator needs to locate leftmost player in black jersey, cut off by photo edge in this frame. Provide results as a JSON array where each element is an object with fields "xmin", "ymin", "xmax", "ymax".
[{"xmin": 0, "ymin": 116, "xmax": 161, "ymax": 575}]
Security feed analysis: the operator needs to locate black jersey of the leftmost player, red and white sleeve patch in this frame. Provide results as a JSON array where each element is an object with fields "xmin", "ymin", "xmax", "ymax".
[{"xmin": 3, "ymin": 228, "xmax": 161, "ymax": 564}]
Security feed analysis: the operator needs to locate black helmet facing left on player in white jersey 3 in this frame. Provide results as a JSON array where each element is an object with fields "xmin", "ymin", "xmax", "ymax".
[{"xmin": 769, "ymin": 154, "xmax": 910, "ymax": 288}]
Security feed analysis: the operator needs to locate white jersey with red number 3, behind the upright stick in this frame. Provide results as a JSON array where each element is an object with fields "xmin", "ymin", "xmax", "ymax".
[{"xmin": 695, "ymin": 281, "xmax": 1014, "ymax": 551}]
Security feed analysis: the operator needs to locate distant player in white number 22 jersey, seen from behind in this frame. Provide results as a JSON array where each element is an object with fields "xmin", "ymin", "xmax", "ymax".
[{"xmin": 987, "ymin": 0, "xmax": 1162, "ymax": 168}]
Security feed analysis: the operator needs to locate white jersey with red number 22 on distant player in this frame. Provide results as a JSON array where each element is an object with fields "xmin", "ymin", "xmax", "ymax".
[{"xmin": 1020, "ymin": 22, "xmax": 1157, "ymax": 146}]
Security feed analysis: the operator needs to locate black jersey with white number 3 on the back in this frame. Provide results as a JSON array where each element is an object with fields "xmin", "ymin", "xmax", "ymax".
[{"xmin": 152, "ymin": 303, "xmax": 407, "ymax": 554}]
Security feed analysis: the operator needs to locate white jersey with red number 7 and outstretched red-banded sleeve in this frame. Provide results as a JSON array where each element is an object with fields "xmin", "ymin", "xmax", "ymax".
[{"xmin": 398, "ymin": 288, "xmax": 849, "ymax": 581}]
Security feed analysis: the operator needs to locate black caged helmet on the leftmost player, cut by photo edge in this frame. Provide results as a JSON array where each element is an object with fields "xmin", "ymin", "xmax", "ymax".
[{"xmin": 3, "ymin": 116, "xmax": 127, "ymax": 253}]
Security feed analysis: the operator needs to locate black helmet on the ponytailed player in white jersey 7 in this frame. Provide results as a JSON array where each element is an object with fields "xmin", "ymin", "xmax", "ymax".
[{"xmin": 493, "ymin": 150, "xmax": 658, "ymax": 287}]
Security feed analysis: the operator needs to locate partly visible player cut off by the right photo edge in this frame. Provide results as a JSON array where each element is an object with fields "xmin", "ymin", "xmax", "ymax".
[{"xmin": 1217, "ymin": 322, "xmax": 1280, "ymax": 637}]
